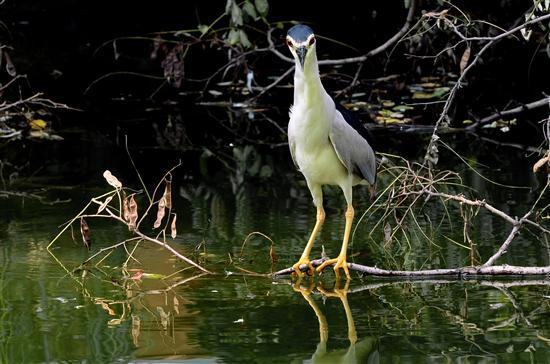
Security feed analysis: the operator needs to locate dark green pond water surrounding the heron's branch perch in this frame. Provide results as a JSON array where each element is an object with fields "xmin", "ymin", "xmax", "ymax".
[{"xmin": 0, "ymin": 106, "xmax": 550, "ymax": 363}]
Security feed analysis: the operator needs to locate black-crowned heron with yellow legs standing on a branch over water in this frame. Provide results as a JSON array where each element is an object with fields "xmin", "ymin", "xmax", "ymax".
[{"xmin": 286, "ymin": 24, "xmax": 376, "ymax": 279}]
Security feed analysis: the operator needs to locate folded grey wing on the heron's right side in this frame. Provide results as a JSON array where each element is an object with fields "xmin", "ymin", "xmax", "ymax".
[{"xmin": 329, "ymin": 110, "xmax": 376, "ymax": 184}]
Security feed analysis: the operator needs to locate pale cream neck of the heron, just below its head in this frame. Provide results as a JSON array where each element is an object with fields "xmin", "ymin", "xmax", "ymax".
[{"xmin": 294, "ymin": 54, "xmax": 326, "ymax": 106}]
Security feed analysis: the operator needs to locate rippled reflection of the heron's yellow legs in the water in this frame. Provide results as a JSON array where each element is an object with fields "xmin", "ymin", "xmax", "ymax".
[{"xmin": 293, "ymin": 279, "xmax": 380, "ymax": 363}]
